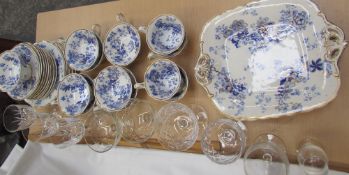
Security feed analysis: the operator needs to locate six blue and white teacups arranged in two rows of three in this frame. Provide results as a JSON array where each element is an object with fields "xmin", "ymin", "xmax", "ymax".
[{"xmin": 58, "ymin": 14, "xmax": 188, "ymax": 116}]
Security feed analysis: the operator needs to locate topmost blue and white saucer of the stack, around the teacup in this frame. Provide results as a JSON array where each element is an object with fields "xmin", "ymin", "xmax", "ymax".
[{"xmin": 7, "ymin": 43, "xmax": 42, "ymax": 100}]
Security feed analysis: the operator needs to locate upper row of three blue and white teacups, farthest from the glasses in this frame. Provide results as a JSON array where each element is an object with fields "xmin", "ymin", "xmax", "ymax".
[{"xmin": 65, "ymin": 14, "xmax": 186, "ymax": 71}]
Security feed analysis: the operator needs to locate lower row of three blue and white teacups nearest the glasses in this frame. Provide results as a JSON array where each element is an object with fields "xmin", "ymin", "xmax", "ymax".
[{"xmin": 58, "ymin": 59, "xmax": 188, "ymax": 116}]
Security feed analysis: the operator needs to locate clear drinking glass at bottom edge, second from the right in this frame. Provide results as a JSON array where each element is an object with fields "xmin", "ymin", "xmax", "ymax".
[{"xmin": 244, "ymin": 134, "xmax": 289, "ymax": 175}]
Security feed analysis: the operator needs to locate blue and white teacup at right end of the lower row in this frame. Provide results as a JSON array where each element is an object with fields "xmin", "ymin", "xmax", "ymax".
[{"xmin": 135, "ymin": 59, "xmax": 189, "ymax": 101}]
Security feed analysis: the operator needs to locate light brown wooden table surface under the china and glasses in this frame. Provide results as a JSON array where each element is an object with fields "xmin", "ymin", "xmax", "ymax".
[{"xmin": 30, "ymin": 0, "xmax": 349, "ymax": 172}]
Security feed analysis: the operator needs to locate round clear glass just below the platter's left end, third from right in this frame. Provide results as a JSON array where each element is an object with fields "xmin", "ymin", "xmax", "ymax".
[{"xmin": 201, "ymin": 119, "xmax": 246, "ymax": 164}]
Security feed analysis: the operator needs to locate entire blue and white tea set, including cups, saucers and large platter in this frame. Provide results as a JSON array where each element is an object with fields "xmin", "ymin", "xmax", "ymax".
[{"xmin": 0, "ymin": 0, "xmax": 346, "ymax": 120}]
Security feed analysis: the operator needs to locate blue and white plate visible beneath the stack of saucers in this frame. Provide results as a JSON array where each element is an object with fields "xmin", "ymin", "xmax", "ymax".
[{"xmin": 25, "ymin": 41, "xmax": 71, "ymax": 106}]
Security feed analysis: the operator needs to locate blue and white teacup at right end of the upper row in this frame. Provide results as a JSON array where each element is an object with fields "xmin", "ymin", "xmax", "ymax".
[{"xmin": 139, "ymin": 14, "xmax": 186, "ymax": 58}]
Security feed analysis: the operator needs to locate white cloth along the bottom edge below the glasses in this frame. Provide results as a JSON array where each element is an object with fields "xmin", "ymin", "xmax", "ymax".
[{"xmin": 3, "ymin": 142, "xmax": 347, "ymax": 175}]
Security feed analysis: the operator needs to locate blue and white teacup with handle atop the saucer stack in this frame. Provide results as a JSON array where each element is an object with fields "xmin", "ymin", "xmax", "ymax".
[{"xmin": 0, "ymin": 51, "xmax": 32, "ymax": 92}]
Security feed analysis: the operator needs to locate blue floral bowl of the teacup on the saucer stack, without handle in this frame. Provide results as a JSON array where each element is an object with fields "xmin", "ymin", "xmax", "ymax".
[{"xmin": 0, "ymin": 51, "xmax": 21, "ymax": 91}]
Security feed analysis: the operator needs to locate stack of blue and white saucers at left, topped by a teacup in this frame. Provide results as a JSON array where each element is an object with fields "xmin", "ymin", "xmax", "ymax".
[{"xmin": 0, "ymin": 43, "xmax": 58, "ymax": 100}]
